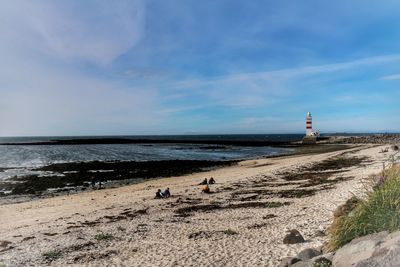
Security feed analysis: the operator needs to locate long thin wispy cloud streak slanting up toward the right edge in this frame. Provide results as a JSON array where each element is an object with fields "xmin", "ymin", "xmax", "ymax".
[{"xmin": 161, "ymin": 54, "xmax": 400, "ymax": 108}]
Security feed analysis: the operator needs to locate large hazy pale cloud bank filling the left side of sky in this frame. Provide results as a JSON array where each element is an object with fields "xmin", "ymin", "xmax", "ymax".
[{"xmin": 0, "ymin": 0, "xmax": 162, "ymax": 136}]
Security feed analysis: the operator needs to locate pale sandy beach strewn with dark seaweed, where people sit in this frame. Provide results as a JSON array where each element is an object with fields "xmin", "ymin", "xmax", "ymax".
[{"xmin": 0, "ymin": 145, "xmax": 390, "ymax": 266}]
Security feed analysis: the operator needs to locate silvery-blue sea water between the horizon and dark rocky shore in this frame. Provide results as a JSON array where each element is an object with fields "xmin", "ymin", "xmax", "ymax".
[{"xmin": 0, "ymin": 135, "xmax": 303, "ymax": 180}]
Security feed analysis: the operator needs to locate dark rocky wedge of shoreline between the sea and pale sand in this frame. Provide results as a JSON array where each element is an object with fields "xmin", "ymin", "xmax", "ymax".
[{"xmin": 0, "ymin": 160, "xmax": 237, "ymax": 205}]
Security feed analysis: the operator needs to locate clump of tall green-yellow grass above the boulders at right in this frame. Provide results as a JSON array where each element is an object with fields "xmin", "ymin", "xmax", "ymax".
[{"xmin": 328, "ymin": 166, "xmax": 400, "ymax": 251}]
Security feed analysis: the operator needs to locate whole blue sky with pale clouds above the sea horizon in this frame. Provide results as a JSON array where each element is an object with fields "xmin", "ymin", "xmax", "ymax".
[{"xmin": 0, "ymin": 0, "xmax": 400, "ymax": 136}]
